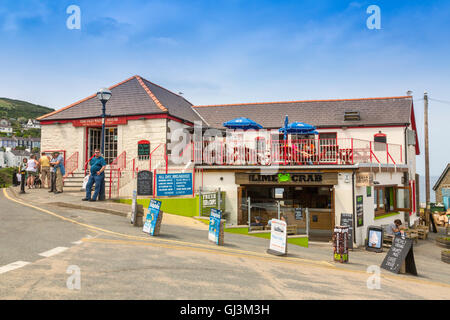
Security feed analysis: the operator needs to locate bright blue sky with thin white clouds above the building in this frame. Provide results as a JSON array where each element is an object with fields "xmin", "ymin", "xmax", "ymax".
[{"xmin": 0, "ymin": 0, "xmax": 450, "ymax": 176}]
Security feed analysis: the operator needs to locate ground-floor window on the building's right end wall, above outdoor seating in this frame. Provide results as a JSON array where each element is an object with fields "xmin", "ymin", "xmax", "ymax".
[{"xmin": 373, "ymin": 186, "xmax": 411, "ymax": 217}]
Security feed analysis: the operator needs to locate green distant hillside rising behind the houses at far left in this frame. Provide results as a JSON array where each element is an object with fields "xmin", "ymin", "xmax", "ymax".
[{"xmin": 0, "ymin": 98, "xmax": 54, "ymax": 119}]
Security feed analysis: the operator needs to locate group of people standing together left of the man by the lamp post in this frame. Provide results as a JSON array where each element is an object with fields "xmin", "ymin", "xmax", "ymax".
[{"xmin": 17, "ymin": 151, "xmax": 65, "ymax": 193}]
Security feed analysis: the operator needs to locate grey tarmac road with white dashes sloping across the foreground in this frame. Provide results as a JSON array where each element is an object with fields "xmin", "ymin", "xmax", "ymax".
[{"xmin": 0, "ymin": 188, "xmax": 450, "ymax": 300}]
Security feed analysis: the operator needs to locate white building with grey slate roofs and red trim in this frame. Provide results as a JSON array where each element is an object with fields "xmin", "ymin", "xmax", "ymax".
[{"xmin": 38, "ymin": 76, "xmax": 419, "ymax": 245}]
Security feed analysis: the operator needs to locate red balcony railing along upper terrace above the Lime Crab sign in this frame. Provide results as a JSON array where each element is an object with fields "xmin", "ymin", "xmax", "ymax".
[{"xmin": 193, "ymin": 138, "xmax": 403, "ymax": 166}]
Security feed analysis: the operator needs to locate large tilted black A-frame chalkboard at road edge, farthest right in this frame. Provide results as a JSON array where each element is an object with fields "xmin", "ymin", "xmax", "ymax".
[{"xmin": 381, "ymin": 236, "xmax": 417, "ymax": 276}]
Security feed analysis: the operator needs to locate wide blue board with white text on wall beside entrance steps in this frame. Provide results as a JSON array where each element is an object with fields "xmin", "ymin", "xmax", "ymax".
[{"xmin": 156, "ymin": 173, "xmax": 192, "ymax": 197}]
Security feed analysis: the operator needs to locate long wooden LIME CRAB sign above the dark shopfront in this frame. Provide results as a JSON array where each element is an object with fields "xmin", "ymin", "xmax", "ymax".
[{"xmin": 235, "ymin": 172, "xmax": 338, "ymax": 185}]
